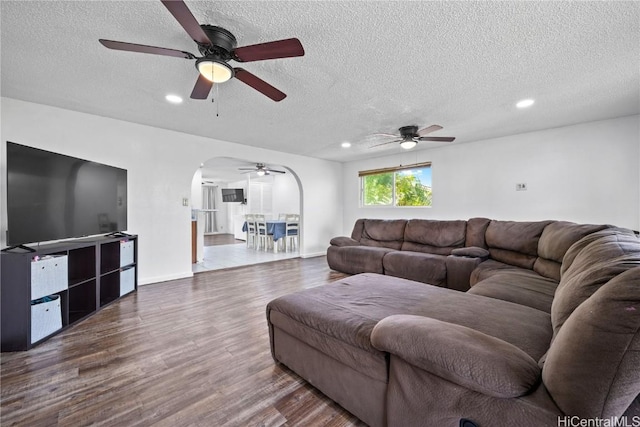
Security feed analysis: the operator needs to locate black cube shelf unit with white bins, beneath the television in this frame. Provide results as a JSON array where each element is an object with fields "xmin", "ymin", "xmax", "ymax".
[{"xmin": 0, "ymin": 235, "xmax": 138, "ymax": 352}]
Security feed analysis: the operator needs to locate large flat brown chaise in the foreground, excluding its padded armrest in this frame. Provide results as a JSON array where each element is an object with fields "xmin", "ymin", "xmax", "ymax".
[{"xmin": 267, "ymin": 273, "xmax": 552, "ymax": 426}]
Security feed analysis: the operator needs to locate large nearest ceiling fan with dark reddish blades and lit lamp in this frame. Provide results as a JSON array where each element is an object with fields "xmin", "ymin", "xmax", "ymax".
[{"xmin": 99, "ymin": 0, "xmax": 304, "ymax": 102}]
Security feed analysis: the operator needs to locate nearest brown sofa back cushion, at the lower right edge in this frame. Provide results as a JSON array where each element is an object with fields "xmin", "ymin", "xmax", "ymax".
[{"xmin": 542, "ymin": 267, "xmax": 640, "ymax": 419}]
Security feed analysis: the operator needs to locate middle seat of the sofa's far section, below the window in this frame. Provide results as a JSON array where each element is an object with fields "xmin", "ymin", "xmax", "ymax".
[{"xmin": 382, "ymin": 251, "xmax": 447, "ymax": 286}]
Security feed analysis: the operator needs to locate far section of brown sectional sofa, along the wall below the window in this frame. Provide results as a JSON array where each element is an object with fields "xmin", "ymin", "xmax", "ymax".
[{"xmin": 327, "ymin": 218, "xmax": 611, "ymax": 291}]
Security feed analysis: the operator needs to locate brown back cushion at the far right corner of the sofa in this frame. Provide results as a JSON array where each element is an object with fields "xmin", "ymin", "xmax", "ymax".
[{"xmin": 533, "ymin": 221, "xmax": 611, "ymax": 282}]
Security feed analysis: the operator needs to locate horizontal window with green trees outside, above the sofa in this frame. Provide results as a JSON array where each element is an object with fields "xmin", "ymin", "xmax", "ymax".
[{"xmin": 358, "ymin": 163, "xmax": 431, "ymax": 206}]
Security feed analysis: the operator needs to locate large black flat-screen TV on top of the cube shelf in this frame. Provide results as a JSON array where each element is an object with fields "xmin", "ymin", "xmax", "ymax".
[{"xmin": 7, "ymin": 142, "xmax": 127, "ymax": 245}]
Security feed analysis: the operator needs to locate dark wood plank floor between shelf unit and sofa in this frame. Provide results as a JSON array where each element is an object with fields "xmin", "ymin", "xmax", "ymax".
[{"xmin": 0, "ymin": 257, "xmax": 362, "ymax": 427}]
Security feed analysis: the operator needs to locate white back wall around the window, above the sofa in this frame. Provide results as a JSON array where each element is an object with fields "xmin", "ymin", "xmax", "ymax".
[{"xmin": 343, "ymin": 115, "xmax": 640, "ymax": 235}]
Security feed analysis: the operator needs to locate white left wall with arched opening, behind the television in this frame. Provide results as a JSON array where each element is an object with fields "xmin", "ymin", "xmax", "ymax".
[{"xmin": 0, "ymin": 97, "xmax": 342, "ymax": 284}]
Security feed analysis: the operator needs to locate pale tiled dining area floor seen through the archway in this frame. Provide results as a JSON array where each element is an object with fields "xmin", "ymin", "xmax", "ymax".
[{"xmin": 192, "ymin": 236, "xmax": 300, "ymax": 273}]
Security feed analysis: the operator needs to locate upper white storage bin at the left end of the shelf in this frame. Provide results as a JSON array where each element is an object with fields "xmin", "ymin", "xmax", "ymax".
[{"xmin": 31, "ymin": 255, "xmax": 69, "ymax": 300}]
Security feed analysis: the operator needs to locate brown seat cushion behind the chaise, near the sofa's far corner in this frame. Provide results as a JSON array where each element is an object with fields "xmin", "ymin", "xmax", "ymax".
[{"xmin": 468, "ymin": 269, "xmax": 558, "ymax": 313}]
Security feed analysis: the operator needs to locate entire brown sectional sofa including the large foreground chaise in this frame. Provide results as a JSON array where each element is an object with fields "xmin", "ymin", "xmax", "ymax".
[{"xmin": 267, "ymin": 219, "xmax": 640, "ymax": 427}]
